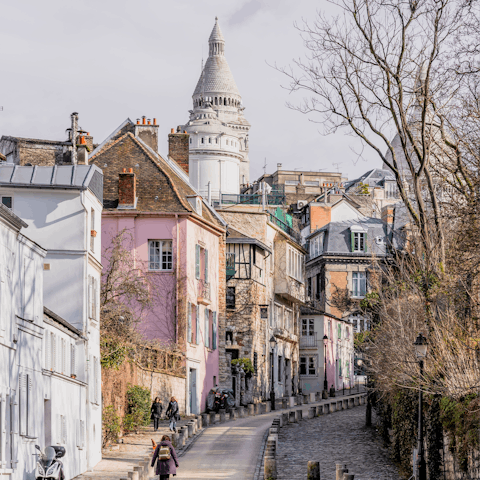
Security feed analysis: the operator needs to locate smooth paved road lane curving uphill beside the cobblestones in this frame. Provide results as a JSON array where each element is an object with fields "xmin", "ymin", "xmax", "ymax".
[{"xmin": 175, "ymin": 412, "xmax": 278, "ymax": 480}]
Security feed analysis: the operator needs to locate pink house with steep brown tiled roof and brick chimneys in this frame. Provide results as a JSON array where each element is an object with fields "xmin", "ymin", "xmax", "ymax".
[{"xmin": 89, "ymin": 119, "xmax": 225, "ymax": 414}]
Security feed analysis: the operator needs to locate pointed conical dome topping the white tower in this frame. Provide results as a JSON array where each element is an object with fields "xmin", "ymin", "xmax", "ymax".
[{"xmin": 193, "ymin": 18, "xmax": 241, "ymax": 98}]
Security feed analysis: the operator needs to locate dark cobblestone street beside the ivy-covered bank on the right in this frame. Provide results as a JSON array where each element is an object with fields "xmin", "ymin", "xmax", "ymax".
[{"xmin": 277, "ymin": 407, "xmax": 401, "ymax": 480}]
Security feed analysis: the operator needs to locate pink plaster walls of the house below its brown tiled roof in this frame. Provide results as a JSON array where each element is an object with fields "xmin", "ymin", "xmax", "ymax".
[{"xmin": 102, "ymin": 214, "xmax": 220, "ymax": 411}]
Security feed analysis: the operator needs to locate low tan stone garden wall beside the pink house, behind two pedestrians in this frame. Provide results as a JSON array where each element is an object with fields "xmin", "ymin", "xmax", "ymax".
[{"xmin": 102, "ymin": 361, "xmax": 186, "ymax": 418}]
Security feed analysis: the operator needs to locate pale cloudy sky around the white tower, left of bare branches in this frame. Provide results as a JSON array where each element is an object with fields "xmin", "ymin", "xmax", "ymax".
[{"xmin": 0, "ymin": 0, "xmax": 381, "ymax": 180}]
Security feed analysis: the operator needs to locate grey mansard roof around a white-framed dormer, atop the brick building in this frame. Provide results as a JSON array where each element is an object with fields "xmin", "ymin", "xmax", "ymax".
[{"xmin": 307, "ymin": 217, "xmax": 389, "ymax": 257}]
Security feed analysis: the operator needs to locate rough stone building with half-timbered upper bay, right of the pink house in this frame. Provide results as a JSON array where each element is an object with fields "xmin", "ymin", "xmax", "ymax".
[{"xmin": 218, "ymin": 205, "xmax": 306, "ymax": 404}]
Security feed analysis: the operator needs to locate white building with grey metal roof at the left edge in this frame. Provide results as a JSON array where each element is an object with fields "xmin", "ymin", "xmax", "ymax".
[{"xmin": 0, "ymin": 165, "xmax": 103, "ymax": 479}]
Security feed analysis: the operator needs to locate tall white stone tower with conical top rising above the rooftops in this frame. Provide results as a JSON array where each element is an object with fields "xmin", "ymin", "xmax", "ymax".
[{"xmin": 181, "ymin": 19, "xmax": 250, "ymax": 199}]
